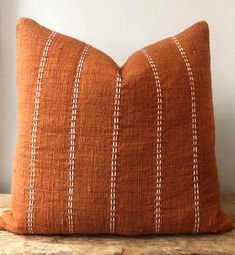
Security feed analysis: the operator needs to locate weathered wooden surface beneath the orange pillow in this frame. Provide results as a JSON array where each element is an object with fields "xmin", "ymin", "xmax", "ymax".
[{"xmin": 0, "ymin": 194, "xmax": 235, "ymax": 255}]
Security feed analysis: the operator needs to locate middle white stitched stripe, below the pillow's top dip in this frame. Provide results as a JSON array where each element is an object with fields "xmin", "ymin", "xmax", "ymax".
[{"xmin": 109, "ymin": 72, "xmax": 122, "ymax": 233}]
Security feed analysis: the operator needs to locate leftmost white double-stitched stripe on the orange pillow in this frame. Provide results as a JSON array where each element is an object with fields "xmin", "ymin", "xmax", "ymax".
[{"xmin": 27, "ymin": 32, "xmax": 56, "ymax": 234}]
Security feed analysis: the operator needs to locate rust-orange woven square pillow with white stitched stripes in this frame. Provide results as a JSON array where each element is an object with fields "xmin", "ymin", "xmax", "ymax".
[{"xmin": 0, "ymin": 18, "xmax": 231, "ymax": 235}]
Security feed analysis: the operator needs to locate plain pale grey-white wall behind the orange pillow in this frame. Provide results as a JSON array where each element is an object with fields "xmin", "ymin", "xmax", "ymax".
[{"xmin": 0, "ymin": 0, "xmax": 235, "ymax": 193}]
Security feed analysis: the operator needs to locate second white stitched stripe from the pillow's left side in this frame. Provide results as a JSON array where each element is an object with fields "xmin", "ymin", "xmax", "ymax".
[{"xmin": 67, "ymin": 45, "xmax": 89, "ymax": 232}]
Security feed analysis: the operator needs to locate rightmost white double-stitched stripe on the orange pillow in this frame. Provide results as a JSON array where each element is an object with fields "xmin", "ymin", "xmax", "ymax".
[{"xmin": 171, "ymin": 36, "xmax": 200, "ymax": 233}]
